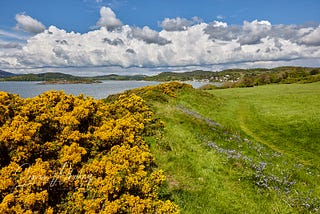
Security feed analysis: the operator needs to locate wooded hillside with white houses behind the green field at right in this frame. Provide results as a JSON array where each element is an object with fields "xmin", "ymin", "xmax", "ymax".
[{"xmin": 145, "ymin": 66, "xmax": 320, "ymax": 87}]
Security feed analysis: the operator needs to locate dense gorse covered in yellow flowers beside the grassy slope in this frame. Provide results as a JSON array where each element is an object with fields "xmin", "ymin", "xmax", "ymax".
[{"xmin": 0, "ymin": 87, "xmax": 179, "ymax": 213}]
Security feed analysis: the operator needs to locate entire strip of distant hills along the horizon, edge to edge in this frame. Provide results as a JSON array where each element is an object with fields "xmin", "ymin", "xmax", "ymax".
[{"xmin": 0, "ymin": 66, "xmax": 320, "ymax": 87}]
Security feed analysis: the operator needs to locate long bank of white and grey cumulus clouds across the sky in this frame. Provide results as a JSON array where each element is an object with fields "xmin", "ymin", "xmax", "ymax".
[{"xmin": 0, "ymin": 7, "xmax": 320, "ymax": 73}]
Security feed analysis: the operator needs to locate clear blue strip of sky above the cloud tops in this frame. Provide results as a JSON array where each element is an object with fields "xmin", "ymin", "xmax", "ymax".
[{"xmin": 0, "ymin": 0, "xmax": 320, "ymax": 33}]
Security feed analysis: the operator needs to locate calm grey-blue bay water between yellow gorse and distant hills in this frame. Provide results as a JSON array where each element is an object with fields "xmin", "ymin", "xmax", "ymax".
[{"xmin": 0, "ymin": 80, "xmax": 203, "ymax": 99}]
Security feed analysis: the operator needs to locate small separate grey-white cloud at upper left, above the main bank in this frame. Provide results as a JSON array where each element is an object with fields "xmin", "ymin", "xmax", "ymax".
[{"xmin": 15, "ymin": 14, "xmax": 46, "ymax": 34}]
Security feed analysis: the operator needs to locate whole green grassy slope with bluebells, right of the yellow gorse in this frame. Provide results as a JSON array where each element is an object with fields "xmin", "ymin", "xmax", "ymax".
[{"xmin": 147, "ymin": 83, "xmax": 320, "ymax": 213}]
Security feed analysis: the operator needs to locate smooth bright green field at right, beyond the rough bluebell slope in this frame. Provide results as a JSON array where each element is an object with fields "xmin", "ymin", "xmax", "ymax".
[{"xmin": 210, "ymin": 82, "xmax": 320, "ymax": 167}]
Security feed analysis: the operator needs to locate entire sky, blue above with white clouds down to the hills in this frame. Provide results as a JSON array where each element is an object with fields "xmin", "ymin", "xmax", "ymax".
[{"xmin": 0, "ymin": 0, "xmax": 320, "ymax": 76}]
